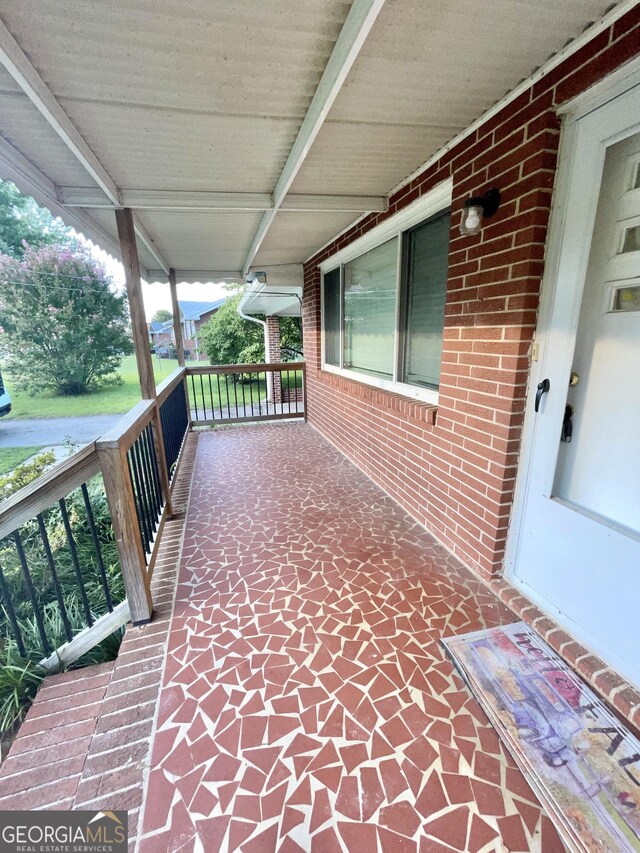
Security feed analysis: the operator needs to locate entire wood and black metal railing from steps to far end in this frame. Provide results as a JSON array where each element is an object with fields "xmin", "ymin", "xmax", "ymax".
[{"xmin": 0, "ymin": 362, "xmax": 306, "ymax": 669}]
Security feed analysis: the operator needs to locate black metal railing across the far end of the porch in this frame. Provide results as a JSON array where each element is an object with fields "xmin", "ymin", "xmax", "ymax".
[{"xmin": 187, "ymin": 362, "xmax": 305, "ymax": 426}]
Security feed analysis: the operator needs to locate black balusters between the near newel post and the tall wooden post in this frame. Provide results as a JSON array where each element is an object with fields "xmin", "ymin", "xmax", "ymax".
[{"xmin": 127, "ymin": 423, "xmax": 164, "ymax": 560}]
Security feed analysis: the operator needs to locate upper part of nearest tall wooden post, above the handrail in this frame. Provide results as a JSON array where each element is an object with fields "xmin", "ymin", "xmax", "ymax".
[{"xmin": 116, "ymin": 207, "xmax": 156, "ymax": 400}]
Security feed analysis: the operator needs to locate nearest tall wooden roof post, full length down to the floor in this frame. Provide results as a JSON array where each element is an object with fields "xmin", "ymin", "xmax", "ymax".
[{"xmin": 116, "ymin": 207, "xmax": 173, "ymax": 517}]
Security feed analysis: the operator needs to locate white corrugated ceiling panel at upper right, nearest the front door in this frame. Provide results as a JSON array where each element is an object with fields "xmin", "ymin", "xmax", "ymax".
[{"xmin": 329, "ymin": 0, "xmax": 611, "ymax": 129}]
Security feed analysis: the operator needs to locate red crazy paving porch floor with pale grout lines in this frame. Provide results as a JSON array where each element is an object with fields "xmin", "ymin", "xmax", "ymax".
[{"xmin": 139, "ymin": 424, "xmax": 563, "ymax": 853}]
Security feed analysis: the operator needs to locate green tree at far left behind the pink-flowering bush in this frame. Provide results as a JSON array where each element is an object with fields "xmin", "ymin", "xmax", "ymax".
[{"xmin": 0, "ymin": 181, "xmax": 71, "ymax": 258}]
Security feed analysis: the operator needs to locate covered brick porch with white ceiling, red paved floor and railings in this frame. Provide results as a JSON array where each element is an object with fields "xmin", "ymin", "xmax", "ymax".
[{"xmin": 0, "ymin": 0, "xmax": 640, "ymax": 853}]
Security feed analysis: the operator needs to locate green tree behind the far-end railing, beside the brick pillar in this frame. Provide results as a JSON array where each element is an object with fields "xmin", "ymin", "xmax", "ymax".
[{"xmin": 200, "ymin": 293, "xmax": 302, "ymax": 364}]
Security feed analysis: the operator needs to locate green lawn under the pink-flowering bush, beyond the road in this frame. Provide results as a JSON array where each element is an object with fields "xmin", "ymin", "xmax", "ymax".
[{"xmin": 3, "ymin": 355, "xmax": 178, "ymax": 420}]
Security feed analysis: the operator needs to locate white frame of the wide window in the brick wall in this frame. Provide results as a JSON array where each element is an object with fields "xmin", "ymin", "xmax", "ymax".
[{"xmin": 320, "ymin": 178, "xmax": 453, "ymax": 404}]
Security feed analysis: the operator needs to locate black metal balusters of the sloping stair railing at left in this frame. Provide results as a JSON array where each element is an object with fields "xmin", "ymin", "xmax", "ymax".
[{"xmin": 0, "ymin": 466, "xmax": 125, "ymax": 659}]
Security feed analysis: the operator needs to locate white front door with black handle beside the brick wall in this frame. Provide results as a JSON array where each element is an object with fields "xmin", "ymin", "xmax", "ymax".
[{"xmin": 506, "ymin": 80, "xmax": 640, "ymax": 685}]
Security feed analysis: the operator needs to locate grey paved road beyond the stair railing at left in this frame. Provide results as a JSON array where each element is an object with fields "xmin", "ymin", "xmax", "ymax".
[{"xmin": 0, "ymin": 415, "xmax": 122, "ymax": 447}]
